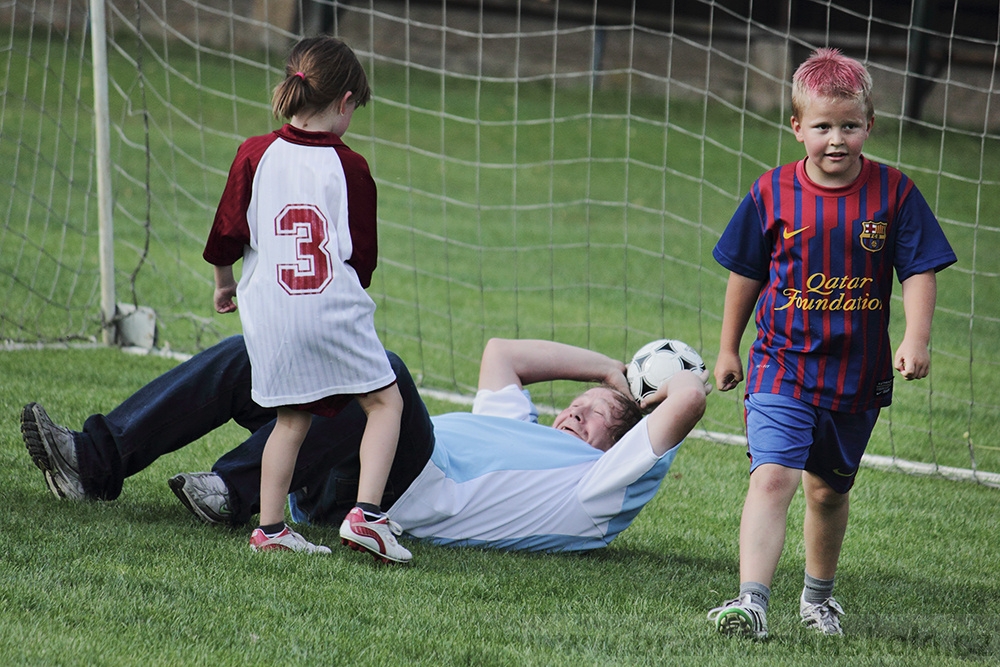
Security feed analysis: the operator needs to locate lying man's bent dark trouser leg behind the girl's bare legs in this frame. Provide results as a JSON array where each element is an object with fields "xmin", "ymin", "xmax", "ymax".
[{"xmin": 212, "ymin": 352, "xmax": 434, "ymax": 525}]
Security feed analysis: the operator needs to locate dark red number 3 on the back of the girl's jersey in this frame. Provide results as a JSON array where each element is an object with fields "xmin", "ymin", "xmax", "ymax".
[{"xmin": 274, "ymin": 204, "xmax": 333, "ymax": 294}]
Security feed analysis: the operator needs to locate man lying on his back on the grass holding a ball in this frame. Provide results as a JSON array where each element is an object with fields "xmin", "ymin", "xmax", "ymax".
[{"xmin": 21, "ymin": 336, "xmax": 710, "ymax": 551}]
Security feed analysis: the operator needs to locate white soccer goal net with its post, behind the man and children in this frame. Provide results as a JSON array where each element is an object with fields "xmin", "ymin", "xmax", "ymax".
[{"xmin": 0, "ymin": 0, "xmax": 1000, "ymax": 483}]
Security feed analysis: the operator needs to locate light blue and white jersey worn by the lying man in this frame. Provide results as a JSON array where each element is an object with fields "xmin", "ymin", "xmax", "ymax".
[{"xmin": 389, "ymin": 385, "xmax": 678, "ymax": 551}]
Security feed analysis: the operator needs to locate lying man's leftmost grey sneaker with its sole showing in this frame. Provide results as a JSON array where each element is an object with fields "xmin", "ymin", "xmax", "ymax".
[{"xmin": 21, "ymin": 403, "xmax": 87, "ymax": 500}]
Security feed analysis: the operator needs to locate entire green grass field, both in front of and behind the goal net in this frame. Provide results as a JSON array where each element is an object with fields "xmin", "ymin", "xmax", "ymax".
[{"xmin": 0, "ymin": 23, "xmax": 1000, "ymax": 667}]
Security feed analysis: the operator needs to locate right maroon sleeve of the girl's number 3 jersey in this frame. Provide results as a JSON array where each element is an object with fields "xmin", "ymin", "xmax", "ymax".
[{"xmin": 338, "ymin": 145, "xmax": 378, "ymax": 289}]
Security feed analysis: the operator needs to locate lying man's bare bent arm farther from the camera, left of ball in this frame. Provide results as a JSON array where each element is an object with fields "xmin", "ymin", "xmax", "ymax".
[{"xmin": 479, "ymin": 338, "xmax": 630, "ymax": 395}]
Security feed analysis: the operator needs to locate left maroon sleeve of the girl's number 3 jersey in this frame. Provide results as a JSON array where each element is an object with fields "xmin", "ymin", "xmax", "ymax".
[{"xmin": 202, "ymin": 134, "xmax": 277, "ymax": 266}]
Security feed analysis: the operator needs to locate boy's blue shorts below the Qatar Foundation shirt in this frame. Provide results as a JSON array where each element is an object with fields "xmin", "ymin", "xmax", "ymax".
[{"xmin": 744, "ymin": 393, "xmax": 879, "ymax": 493}]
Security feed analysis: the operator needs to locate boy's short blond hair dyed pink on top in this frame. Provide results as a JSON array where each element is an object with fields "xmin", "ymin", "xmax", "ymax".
[{"xmin": 792, "ymin": 48, "xmax": 875, "ymax": 118}]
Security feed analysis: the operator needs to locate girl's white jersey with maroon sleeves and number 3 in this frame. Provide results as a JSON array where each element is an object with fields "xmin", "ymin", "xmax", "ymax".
[{"xmin": 204, "ymin": 125, "xmax": 395, "ymax": 407}]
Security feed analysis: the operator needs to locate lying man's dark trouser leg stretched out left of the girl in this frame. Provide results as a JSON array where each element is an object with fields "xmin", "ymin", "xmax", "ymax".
[{"xmin": 76, "ymin": 336, "xmax": 274, "ymax": 500}]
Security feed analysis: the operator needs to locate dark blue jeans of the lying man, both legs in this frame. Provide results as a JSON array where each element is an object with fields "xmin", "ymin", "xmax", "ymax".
[{"xmin": 75, "ymin": 336, "xmax": 434, "ymax": 524}]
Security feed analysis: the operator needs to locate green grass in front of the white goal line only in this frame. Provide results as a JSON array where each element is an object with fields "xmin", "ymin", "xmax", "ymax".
[{"xmin": 0, "ymin": 350, "xmax": 1000, "ymax": 667}]
